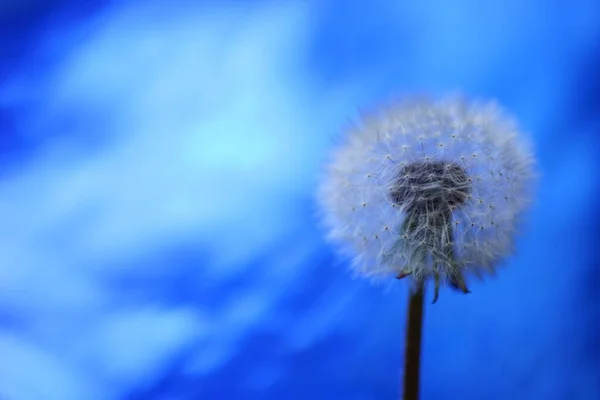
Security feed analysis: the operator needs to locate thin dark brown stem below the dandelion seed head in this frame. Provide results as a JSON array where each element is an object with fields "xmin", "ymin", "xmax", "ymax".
[{"xmin": 402, "ymin": 283, "xmax": 424, "ymax": 400}]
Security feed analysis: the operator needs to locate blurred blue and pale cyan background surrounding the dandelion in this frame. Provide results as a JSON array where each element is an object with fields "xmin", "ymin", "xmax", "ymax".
[{"xmin": 0, "ymin": 0, "xmax": 600, "ymax": 400}]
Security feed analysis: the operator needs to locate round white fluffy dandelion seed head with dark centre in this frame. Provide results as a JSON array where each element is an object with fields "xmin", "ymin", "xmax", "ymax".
[{"xmin": 319, "ymin": 98, "xmax": 536, "ymax": 281}]
